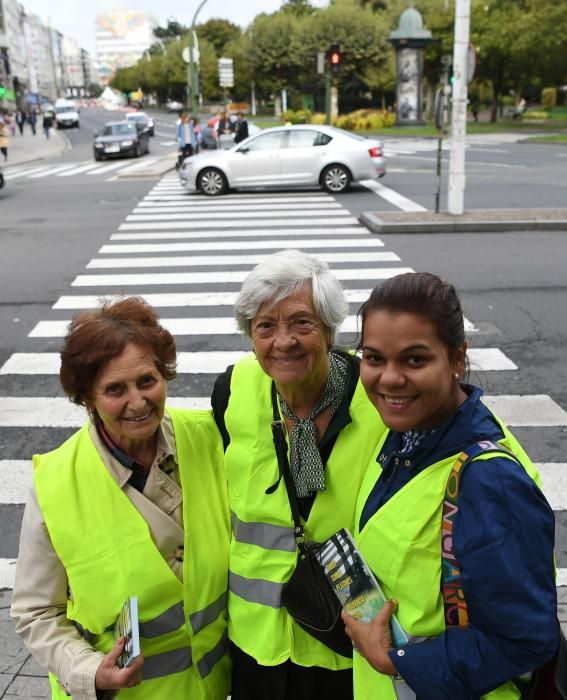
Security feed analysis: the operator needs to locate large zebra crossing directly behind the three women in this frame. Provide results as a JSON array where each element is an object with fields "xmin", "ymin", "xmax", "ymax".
[{"xmin": 0, "ymin": 174, "xmax": 567, "ymax": 589}]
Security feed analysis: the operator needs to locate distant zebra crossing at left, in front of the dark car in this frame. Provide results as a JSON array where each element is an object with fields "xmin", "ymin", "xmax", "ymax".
[{"xmin": 5, "ymin": 156, "xmax": 164, "ymax": 182}]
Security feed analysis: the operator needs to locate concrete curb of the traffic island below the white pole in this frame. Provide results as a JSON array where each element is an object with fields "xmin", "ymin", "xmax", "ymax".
[{"xmin": 358, "ymin": 212, "xmax": 567, "ymax": 233}]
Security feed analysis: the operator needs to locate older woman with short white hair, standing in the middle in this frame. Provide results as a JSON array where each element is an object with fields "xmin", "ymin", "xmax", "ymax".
[{"xmin": 212, "ymin": 250, "xmax": 384, "ymax": 700}]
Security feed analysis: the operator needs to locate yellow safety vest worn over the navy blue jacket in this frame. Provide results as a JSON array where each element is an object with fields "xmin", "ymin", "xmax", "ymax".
[{"xmin": 354, "ymin": 416, "xmax": 541, "ymax": 700}]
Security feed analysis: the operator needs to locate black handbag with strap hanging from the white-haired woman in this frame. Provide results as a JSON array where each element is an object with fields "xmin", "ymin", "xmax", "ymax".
[{"xmin": 267, "ymin": 385, "xmax": 352, "ymax": 657}]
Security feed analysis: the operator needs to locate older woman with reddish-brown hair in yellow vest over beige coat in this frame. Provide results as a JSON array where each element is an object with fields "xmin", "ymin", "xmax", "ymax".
[{"xmin": 12, "ymin": 297, "xmax": 229, "ymax": 700}]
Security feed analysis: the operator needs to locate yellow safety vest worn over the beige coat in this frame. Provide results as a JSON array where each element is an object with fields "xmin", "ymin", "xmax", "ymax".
[{"xmin": 33, "ymin": 409, "xmax": 230, "ymax": 700}]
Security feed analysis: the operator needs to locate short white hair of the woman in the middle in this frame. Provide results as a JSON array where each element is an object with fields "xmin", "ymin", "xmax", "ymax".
[{"xmin": 234, "ymin": 250, "xmax": 348, "ymax": 342}]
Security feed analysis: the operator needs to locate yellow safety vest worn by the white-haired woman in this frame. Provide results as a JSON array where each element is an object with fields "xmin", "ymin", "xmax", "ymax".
[{"xmin": 225, "ymin": 356, "xmax": 385, "ymax": 670}]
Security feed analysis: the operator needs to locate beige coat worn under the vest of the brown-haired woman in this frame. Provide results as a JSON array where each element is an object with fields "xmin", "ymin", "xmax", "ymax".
[{"xmin": 11, "ymin": 413, "xmax": 184, "ymax": 700}]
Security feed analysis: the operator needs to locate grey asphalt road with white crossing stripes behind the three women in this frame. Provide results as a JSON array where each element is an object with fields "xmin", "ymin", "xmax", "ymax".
[{"xmin": 0, "ymin": 110, "xmax": 567, "ymax": 692}]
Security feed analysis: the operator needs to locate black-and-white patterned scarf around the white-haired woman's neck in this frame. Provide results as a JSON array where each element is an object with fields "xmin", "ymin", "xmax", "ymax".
[{"xmin": 280, "ymin": 353, "xmax": 348, "ymax": 498}]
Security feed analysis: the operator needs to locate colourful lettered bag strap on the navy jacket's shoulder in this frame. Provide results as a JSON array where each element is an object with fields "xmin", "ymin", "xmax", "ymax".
[{"xmin": 441, "ymin": 440, "xmax": 520, "ymax": 627}]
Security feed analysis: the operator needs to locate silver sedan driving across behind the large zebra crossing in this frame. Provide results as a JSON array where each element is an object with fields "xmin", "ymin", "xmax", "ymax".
[{"xmin": 179, "ymin": 124, "xmax": 386, "ymax": 196}]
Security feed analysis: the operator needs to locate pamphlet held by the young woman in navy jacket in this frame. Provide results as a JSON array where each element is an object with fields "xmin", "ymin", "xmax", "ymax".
[{"xmin": 319, "ymin": 528, "xmax": 409, "ymax": 647}]
